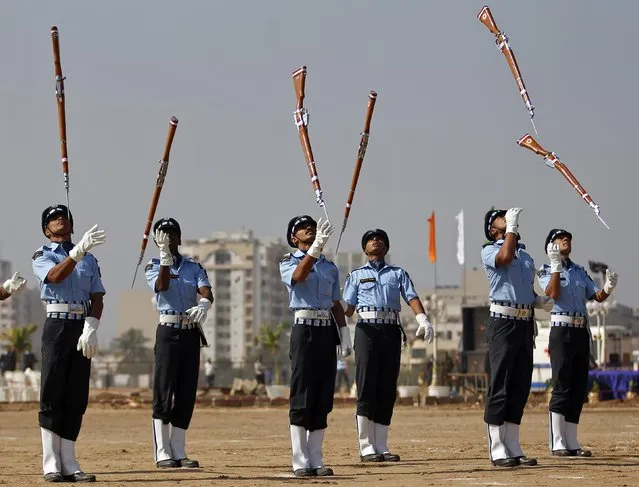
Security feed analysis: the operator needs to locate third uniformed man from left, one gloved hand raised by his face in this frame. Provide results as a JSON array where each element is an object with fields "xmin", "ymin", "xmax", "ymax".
[{"xmin": 280, "ymin": 215, "xmax": 352, "ymax": 477}]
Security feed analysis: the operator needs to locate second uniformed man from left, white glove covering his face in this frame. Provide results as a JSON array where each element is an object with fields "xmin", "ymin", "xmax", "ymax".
[{"xmin": 145, "ymin": 218, "xmax": 213, "ymax": 468}]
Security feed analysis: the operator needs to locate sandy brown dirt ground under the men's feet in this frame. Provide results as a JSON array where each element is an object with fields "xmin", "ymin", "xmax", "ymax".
[{"xmin": 0, "ymin": 405, "xmax": 639, "ymax": 487}]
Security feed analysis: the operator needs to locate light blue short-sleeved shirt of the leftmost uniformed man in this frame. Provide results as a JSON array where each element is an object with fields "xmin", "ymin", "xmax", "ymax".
[{"xmin": 32, "ymin": 242, "xmax": 106, "ymax": 303}]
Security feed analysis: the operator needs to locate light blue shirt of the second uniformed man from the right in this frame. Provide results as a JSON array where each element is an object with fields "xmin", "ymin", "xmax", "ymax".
[{"xmin": 481, "ymin": 239, "xmax": 536, "ymax": 305}]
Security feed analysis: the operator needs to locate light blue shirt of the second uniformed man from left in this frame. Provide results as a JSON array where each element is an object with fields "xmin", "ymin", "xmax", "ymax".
[{"xmin": 144, "ymin": 256, "xmax": 211, "ymax": 313}]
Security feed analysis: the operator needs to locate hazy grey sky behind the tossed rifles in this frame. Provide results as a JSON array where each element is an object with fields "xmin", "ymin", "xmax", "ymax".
[{"xmin": 0, "ymin": 0, "xmax": 639, "ymax": 344}]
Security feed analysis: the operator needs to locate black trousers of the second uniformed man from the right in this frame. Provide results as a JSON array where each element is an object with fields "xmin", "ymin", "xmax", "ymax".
[{"xmin": 484, "ymin": 317, "xmax": 533, "ymax": 425}]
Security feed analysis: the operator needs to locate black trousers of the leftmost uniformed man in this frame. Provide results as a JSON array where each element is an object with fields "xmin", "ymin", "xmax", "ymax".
[{"xmin": 39, "ymin": 318, "xmax": 91, "ymax": 441}]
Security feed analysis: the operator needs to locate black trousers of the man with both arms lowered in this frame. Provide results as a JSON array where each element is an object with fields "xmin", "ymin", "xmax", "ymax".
[{"xmin": 354, "ymin": 322, "xmax": 402, "ymax": 426}]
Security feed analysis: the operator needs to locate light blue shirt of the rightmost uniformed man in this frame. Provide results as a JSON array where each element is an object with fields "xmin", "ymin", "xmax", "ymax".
[{"xmin": 537, "ymin": 259, "xmax": 599, "ymax": 315}]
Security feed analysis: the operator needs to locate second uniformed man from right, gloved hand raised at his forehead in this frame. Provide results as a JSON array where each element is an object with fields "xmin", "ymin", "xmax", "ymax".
[{"xmin": 481, "ymin": 208, "xmax": 551, "ymax": 467}]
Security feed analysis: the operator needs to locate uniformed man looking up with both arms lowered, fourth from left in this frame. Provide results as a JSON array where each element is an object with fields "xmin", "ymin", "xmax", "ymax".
[{"xmin": 344, "ymin": 229, "xmax": 433, "ymax": 462}]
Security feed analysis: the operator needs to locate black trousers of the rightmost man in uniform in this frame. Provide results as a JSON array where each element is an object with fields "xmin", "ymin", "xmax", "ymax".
[{"xmin": 548, "ymin": 326, "xmax": 590, "ymax": 423}]
